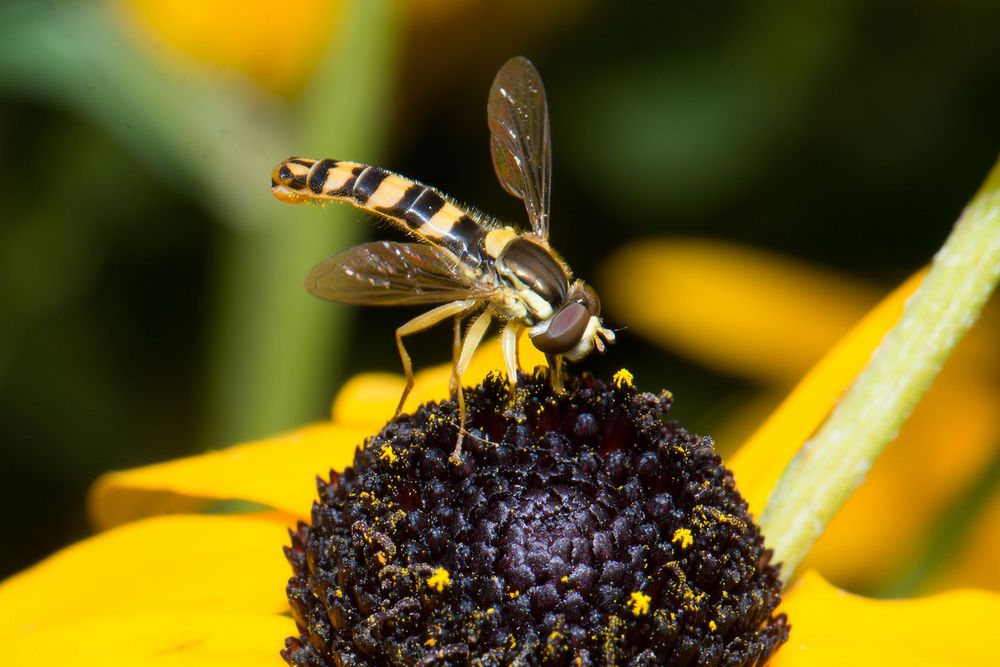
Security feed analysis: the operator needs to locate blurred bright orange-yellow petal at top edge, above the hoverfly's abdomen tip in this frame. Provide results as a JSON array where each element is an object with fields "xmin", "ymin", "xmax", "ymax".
[{"xmin": 119, "ymin": 0, "xmax": 344, "ymax": 93}]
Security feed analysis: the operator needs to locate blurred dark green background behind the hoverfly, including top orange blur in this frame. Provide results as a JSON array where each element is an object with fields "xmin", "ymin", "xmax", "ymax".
[{"xmin": 0, "ymin": 0, "xmax": 1000, "ymax": 575}]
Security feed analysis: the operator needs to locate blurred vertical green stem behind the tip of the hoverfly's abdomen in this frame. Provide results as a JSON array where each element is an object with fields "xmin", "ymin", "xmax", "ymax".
[{"xmin": 205, "ymin": 0, "xmax": 398, "ymax": 446}]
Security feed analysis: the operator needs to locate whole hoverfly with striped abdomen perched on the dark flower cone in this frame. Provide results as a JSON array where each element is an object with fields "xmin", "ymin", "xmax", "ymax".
[{"xmin": 271, "ymin": 57, "xmax": 615, "ymax": 461}]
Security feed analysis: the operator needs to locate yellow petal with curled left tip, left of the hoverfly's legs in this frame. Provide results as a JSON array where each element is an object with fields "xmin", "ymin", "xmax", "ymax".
[{"xmin": 89, "ymin": 423, "xmax": 374, "ymax": 528}]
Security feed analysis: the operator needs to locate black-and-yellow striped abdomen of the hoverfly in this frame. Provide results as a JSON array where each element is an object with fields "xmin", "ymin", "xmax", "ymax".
[{"xmin": 271, "ymin": 157, "xmax": 484, "ymax": 266}]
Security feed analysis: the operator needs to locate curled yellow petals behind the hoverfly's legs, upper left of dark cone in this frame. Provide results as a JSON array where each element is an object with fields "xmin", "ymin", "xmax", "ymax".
[{"xmin": 89, "ymin": 341, "xmax": 545, "ymax": 528}]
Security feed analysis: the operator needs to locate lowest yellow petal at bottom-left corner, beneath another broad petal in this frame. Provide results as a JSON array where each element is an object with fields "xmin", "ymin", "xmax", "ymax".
[{"xmin": 0, "ymin": 610, "xmax": 297, "ymax": 667}]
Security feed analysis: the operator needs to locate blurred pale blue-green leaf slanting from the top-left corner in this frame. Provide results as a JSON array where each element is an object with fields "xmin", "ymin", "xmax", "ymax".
[{"xmin": 0, "ymin": 2, "xmax": 288, "ymax": 223}]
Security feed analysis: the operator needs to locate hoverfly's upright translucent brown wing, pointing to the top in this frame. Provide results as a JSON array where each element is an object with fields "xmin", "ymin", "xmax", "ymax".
[{"xmin": 487, "ymin": 56, "xmax": 552, "ymax": 239}]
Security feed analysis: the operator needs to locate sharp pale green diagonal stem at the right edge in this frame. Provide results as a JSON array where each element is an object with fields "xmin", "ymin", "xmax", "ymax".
[{"xmin": 760, "ymin": 157, "xmax": 1000, "ymax": 582}]
